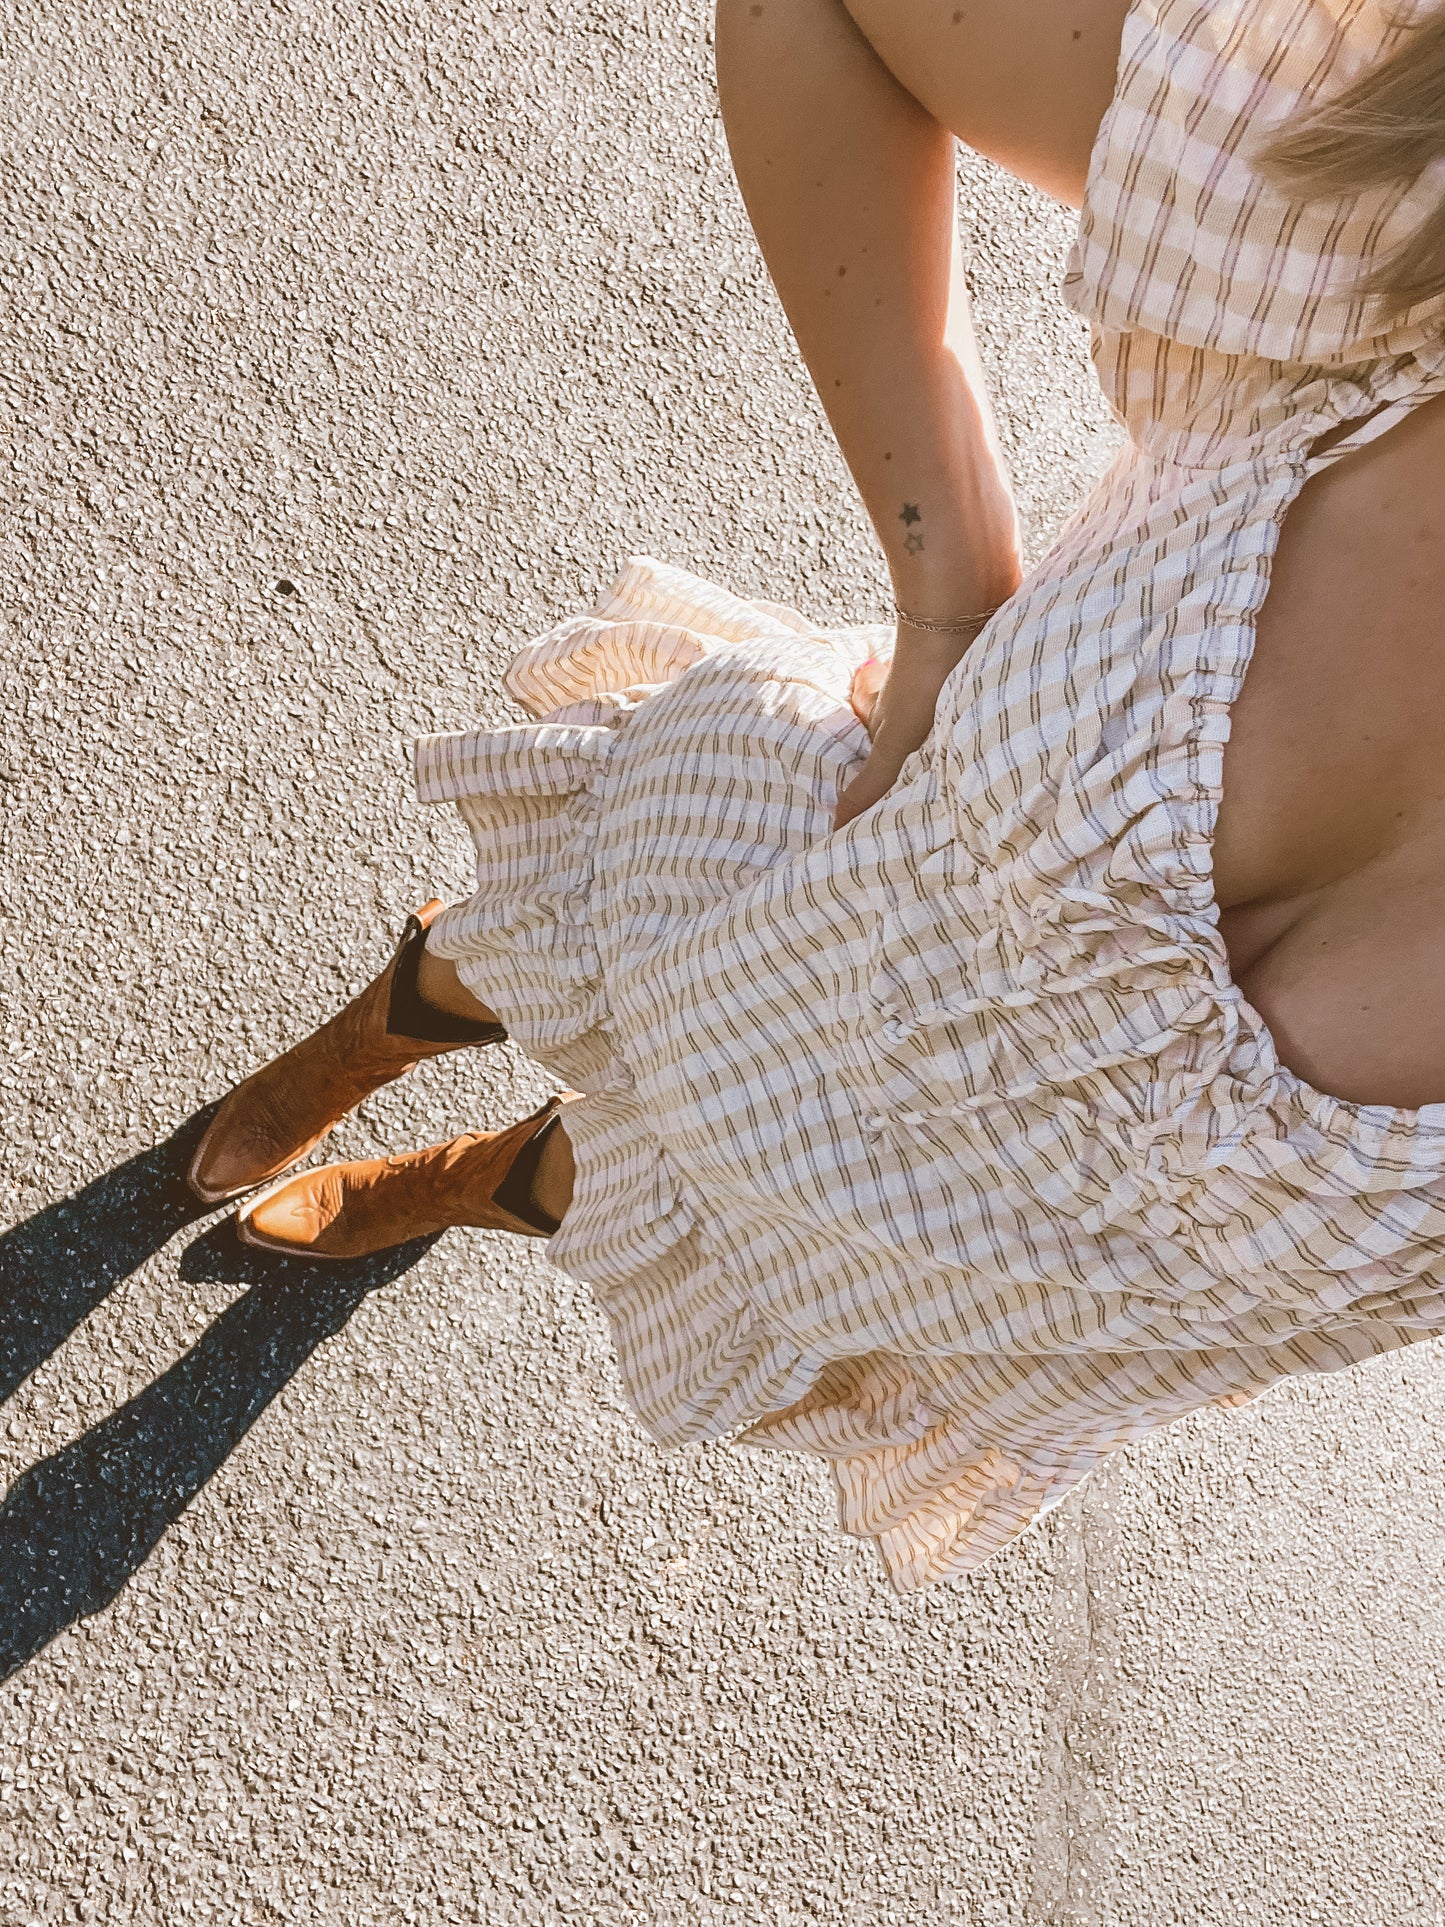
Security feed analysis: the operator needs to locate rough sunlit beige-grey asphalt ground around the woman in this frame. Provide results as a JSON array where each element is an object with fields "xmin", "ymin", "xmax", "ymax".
[{"xmin": 0, "ymin": 0, "xmax": 1445, "ymax": 1927}]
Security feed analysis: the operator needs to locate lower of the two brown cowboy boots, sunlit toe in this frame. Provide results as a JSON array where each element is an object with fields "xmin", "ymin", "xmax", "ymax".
[{"xmin": 235, "ymin": 1096, "xmax": 563, "ymax": 1260}]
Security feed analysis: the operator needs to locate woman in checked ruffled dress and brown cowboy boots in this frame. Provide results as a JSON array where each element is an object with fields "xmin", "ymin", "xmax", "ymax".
[{"xmin": 193, "ymin": 0, "xmax": 1445, "ymax": 1590}]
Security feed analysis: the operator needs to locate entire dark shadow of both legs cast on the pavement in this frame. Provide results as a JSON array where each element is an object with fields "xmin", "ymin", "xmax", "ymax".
[{"xmin": 0, "ymin": 1110, "xmax": 434, "ymax": 1678}]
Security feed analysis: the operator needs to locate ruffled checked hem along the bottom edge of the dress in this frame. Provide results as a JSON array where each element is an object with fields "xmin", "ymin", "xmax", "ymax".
[{"xmin": 416, "ymin": 557, "xmax": 1046, "ymax": 1588}]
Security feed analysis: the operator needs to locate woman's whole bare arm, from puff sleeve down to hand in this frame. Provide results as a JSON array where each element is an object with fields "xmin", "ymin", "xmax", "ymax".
[{"xmin": 717, "ymin": 0, "xmax": 1127, "ymax": 813}]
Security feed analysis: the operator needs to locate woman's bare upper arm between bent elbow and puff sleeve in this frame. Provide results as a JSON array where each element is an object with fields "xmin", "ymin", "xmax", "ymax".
[{"xmin": 843, "ymin": 0, "xmax": 1129, "ymax": 208}]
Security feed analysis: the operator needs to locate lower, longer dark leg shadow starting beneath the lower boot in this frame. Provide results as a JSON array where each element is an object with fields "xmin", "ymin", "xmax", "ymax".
[{"xmin": 0, "ymin": 1225, "xmax": 432, "ymax": 1678}]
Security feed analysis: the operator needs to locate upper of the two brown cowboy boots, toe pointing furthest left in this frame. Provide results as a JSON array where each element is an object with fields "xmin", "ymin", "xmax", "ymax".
[{"xmin": 187, "ymin": 898, "xmax": 507, "ymax": 1204}]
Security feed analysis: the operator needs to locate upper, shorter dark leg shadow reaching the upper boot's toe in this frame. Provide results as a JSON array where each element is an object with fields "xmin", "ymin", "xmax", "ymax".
[{"xmin": 0, "ymin": 1104, "xmax": 216, "ymax": 1403}]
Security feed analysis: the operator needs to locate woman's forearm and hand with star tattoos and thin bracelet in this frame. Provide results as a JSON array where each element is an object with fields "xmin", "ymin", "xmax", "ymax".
[{"xmin": 717, "ymin": 0, "xmax": 1019, "ymax": 823}]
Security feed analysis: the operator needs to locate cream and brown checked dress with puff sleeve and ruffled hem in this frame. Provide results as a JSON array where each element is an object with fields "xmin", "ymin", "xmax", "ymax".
[{"xmin": 416, "ymin": 0, "xmax": 1445, "ymax": 1590}]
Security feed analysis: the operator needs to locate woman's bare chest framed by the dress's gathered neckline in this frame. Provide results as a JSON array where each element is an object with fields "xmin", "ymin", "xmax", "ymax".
[{"xmin": 1214, "ymin": 397, "xmax": 1445, "ymax": 1108}]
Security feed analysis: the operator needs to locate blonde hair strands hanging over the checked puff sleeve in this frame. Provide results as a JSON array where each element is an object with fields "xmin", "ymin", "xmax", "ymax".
[{"xmin": 1256, "ymin": 6, "xmax": 1445, "ymax": 318}]
